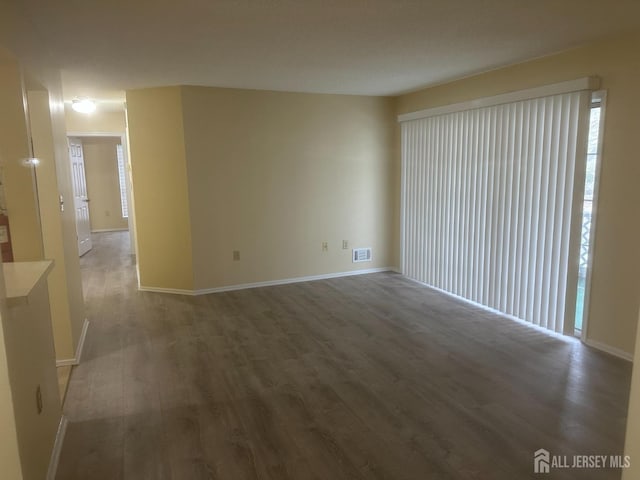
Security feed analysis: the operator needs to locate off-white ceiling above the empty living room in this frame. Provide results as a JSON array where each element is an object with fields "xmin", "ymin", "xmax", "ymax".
[{"xmin": 12, "ymin": 0, "xmax": 640, "ymax": 100}]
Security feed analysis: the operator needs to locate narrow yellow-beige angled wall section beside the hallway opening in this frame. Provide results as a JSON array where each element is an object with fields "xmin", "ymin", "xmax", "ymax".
[{"xmin": 127, "ymin": 87, "xmax": 193, "ymax": 290}]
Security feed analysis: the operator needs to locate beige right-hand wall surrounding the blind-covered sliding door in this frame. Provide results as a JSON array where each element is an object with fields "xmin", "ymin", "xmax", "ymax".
[{"xmin": 396, "ymin": 29, "xmax": 640, "ymax": 354}]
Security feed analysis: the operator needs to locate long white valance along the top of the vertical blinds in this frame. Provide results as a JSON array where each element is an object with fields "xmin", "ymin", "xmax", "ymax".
[{"xmin": 398, "ymin": 77, "xmax": 600, "ymax": 122}]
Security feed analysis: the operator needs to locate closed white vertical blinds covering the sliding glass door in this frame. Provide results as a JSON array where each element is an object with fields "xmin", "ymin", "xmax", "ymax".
[{"xmin": 401, "ymin": 91, "xmax": 589, "ymax": 332}]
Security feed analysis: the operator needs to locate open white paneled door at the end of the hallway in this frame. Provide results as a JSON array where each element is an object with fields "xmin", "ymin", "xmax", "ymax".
[{"xmin": 69, "ymin": 138, "xmax": 91, "ymax": 256}]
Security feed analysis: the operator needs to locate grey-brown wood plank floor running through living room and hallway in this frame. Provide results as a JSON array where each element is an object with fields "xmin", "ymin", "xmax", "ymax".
[{"xmin": 57, "ymin": 232, "xmax": 631, "ymax": 480}]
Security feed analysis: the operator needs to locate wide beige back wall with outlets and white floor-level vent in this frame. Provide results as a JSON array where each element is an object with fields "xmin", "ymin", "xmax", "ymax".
[{"xmin": 180, "ymin": 87, "xmax": 395, "ymax": 289}]
